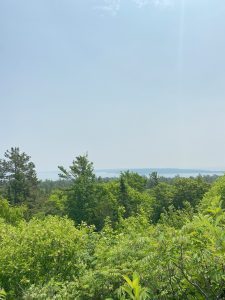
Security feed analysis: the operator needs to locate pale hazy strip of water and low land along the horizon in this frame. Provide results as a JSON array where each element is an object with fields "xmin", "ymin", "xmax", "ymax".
[{"xmin": 37, "ymin": 168, "xmax": 225, "ymax": 180}]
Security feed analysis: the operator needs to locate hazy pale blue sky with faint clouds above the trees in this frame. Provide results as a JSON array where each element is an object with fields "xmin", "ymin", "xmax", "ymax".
[{"xmin": 0, "ymin": 0, "xmax": 225, "ymax": 172}]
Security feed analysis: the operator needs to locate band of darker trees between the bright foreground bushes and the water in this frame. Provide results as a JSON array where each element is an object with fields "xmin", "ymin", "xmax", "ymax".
[{"xmin": 0, "ymin": 148, "xmax": 215, "ymax": 230}]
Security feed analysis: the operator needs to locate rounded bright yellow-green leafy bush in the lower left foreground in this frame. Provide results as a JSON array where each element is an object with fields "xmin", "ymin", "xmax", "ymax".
[{"xmin": 0, "ymin": 217, "xmax": 96, "ymax": 297}]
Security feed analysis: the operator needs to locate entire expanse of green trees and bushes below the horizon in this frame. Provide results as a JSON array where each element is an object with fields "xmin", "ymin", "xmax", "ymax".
[{"xmin": 0, "ymin": 148, "xmax": 225, "ymax": 300}]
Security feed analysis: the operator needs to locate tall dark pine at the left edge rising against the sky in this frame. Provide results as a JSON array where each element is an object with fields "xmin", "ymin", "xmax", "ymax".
[{"xmin": 0, "ymin": 147, "xmax": 38, "ymax": 205}]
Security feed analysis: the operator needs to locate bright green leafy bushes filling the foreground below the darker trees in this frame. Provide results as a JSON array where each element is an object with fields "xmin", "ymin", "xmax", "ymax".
[{"xmin": 0, "ymin": 199, "xmax": 225, "ymax": 300}]
